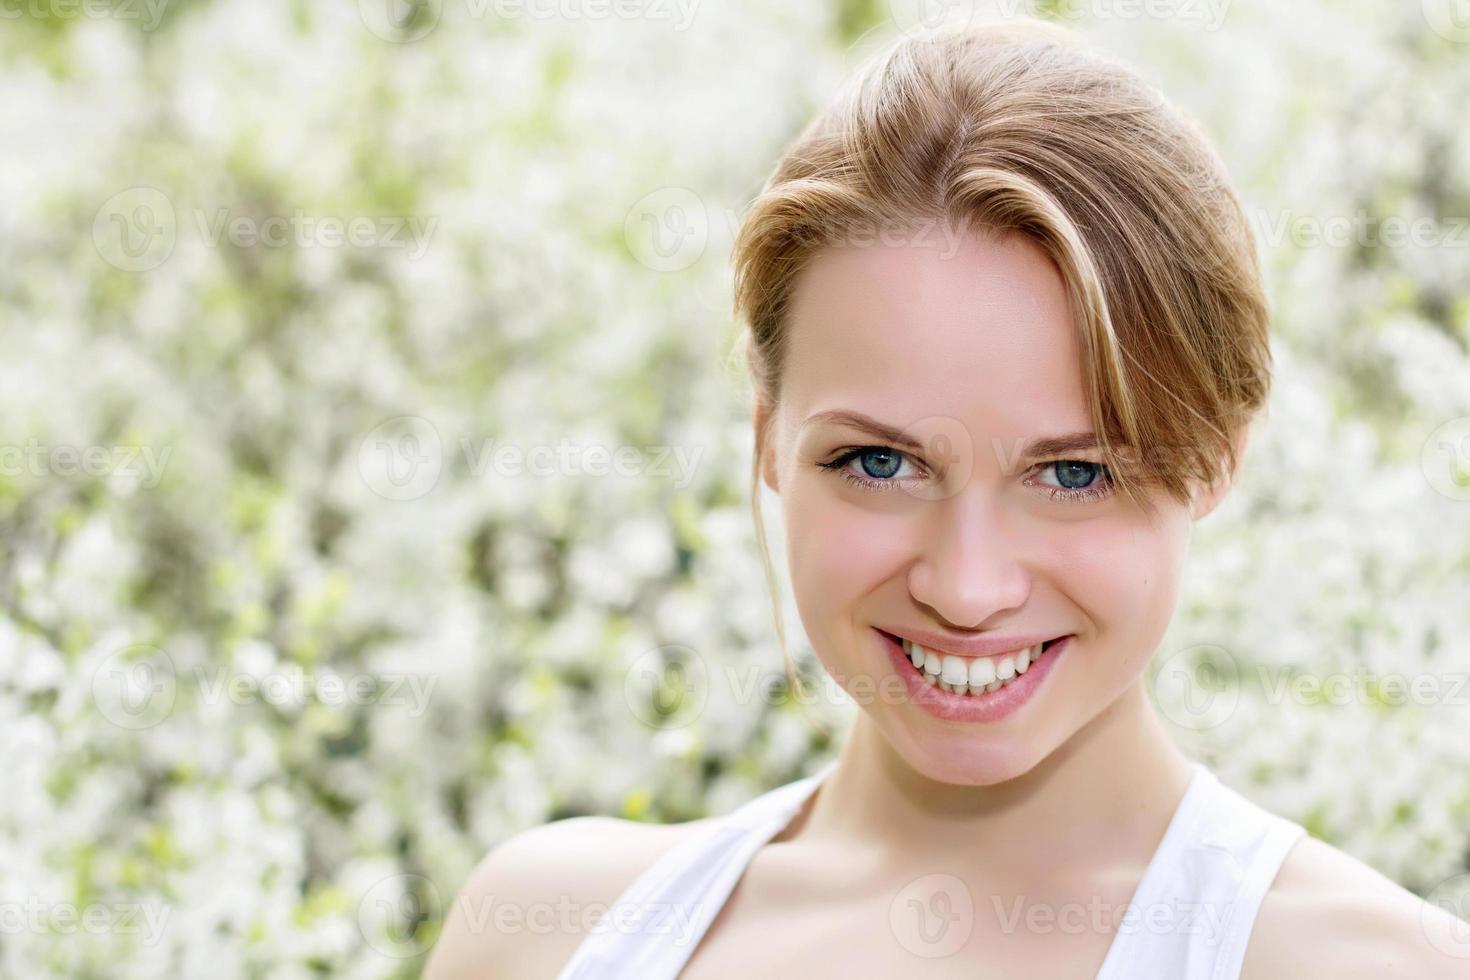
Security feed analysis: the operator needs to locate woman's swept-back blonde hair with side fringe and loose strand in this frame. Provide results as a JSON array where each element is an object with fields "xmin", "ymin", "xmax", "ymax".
[{"xmin": 734, "ymin": 19, "xmax": 1270, "ymax": 719}]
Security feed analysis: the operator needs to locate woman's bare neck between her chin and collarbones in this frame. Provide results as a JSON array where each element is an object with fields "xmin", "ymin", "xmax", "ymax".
[{"xmin": 782, "ymin": 680, "xmax": 1192, "ymax": 884}]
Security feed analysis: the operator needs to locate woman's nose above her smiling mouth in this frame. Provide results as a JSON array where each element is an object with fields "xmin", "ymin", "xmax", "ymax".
[{"xmin": 908, "ymin": 492, "xmax": 1030, "ymax": 629}]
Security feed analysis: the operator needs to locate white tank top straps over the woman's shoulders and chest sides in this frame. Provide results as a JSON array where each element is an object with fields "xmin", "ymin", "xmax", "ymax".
[{"xmin": 557, "ymin": 760, "xmax": 1305, "ymax": 980}]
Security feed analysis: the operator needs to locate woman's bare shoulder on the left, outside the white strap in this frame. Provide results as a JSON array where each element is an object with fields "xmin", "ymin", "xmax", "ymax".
[{"xmin": 423, "ymin": 817, "xmax": 709, "ymax": 980}]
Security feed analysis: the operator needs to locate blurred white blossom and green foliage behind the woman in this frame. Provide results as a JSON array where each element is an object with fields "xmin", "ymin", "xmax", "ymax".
[{"xmin": 0, "ymin": 0, "xmax": 1470, "ymax": 980}]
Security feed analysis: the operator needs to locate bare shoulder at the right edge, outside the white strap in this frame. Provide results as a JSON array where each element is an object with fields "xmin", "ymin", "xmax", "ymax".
[{"xmin": 1241, "ymin": 835, "xmax": 1470, "ymax": 980}]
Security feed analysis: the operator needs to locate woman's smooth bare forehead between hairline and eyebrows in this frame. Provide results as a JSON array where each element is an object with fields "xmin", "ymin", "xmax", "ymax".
[{"xmin": 782, "ymin": 231, "xmax": 1089, "ymax": 435}]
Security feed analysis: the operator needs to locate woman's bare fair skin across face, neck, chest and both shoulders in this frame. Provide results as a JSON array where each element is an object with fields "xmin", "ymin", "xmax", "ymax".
[{"xmin": 425, "ymin": 224, "xmax": 1470, "ymax": 980}]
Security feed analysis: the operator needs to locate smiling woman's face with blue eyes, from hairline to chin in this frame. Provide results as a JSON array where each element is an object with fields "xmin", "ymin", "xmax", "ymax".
[{"xmin": 757, "ymin": 226, "xmax": 1223, "ymax": 785}]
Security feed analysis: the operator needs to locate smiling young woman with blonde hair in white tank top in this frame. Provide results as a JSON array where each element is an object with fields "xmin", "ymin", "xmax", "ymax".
[{"xmin": 428, "ymin": 17, "xmax": 1470, "ymax": 980}]
